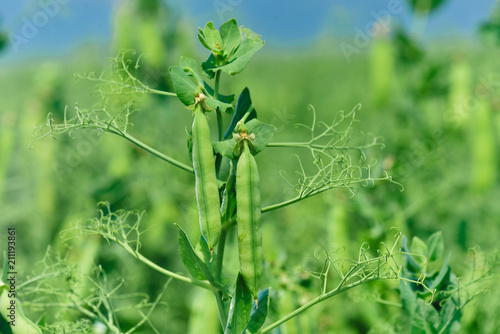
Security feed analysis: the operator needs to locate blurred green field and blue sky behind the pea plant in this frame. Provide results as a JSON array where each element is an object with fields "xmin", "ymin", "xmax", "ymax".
[{"xmin": 0, "ymin": 0, "xmax": 500, "ymax": 333}]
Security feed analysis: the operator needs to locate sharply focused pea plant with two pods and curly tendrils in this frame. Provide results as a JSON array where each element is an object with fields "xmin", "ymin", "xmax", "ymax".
[{"xmin": 10, "ymin": 19, "xmax": 492, "ymax": 334}]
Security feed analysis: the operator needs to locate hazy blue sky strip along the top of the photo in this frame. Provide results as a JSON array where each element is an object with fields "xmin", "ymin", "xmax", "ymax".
[{"xmin": 0, "ymin": 0, "xmax": 495, "ymax": 60}]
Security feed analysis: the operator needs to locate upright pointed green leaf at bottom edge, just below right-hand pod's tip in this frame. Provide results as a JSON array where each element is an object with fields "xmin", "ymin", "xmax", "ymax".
[{"xmin": 224, "ymin": 273, "xmax": 252, "ymax": 334}]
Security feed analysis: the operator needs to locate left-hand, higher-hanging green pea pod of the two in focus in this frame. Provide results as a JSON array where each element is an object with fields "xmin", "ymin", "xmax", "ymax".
[{"xmin": 193, "ymin": 106, "xmax": 221, "ymax": 251}]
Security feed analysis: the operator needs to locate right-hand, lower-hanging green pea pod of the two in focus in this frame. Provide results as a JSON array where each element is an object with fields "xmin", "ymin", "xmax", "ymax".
[{"xmin": 236, "ymin": 139, "xmax": 263, "ymax": 300}]
